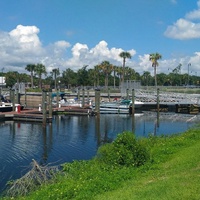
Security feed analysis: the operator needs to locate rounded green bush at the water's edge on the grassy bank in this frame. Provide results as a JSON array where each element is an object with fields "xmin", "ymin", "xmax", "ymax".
[{"xmin": 96, "ymin": 132, "xmax": 150, "ymax": 167}]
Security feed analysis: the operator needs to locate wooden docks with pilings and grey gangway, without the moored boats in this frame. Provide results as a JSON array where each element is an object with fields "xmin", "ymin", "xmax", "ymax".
[{"xmin": 0, "ymin": 89, "xmax": 200, "ymax": 123}]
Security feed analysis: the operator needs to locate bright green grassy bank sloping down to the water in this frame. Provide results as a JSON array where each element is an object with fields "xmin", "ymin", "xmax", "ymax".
[{"xmin": 1, "ymin": 128, "xmax": 200, "ymax": 200}]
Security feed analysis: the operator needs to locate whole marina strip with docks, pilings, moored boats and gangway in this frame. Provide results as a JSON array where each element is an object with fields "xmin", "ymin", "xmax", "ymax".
[{"xmin": 0, "ymin": 90, "xmax": 200, "ymax": 123}]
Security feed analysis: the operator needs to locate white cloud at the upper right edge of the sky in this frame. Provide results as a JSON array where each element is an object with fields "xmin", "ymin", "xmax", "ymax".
[{"xmin": 164, "ymin": 1, "xmax": 200, "ymax": 40}]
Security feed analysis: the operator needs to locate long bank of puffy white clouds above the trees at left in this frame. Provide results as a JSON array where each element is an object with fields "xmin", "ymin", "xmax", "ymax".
[{"xmin": 0, "ymin": 25, "xmax": 136, "ymax": 72}]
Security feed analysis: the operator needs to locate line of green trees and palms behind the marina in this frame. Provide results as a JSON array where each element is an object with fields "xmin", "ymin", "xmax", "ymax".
[{"xmin": 0, "ymin": 52, "xmax": 200, "ymax": 88}]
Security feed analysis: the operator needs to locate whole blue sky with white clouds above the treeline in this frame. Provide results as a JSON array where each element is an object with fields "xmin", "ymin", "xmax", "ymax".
[{"xmin": 0, "ymin": 0, "xmax": 200, "ymax": 75}]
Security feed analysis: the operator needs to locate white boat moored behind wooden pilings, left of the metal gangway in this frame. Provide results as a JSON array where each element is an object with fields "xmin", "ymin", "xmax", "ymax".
[{"xmin": 92, "ymin": 100, "xmax": 144, "ymax": 114}]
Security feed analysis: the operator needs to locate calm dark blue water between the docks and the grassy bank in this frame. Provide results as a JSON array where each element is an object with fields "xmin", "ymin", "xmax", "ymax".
[{"xmin": 0, "ymin": 113, "xmax": 199, "ymax": 192}]
